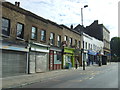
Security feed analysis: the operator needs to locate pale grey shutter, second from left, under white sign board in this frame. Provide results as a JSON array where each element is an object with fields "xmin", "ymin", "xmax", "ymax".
[{"xmin": 30, "ymin": 52, "xmax": 47, "ymax": 73}]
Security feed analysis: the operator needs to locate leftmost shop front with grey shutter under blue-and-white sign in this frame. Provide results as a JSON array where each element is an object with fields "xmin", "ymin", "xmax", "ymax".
[{"xmin": 0, "ymin": 41, "xmax": 29, "ymax": 77}]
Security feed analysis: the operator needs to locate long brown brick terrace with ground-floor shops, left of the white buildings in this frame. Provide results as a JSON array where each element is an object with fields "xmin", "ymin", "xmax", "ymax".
[{"xmin": 0, "ymin": 2, "xmax": 110, "ymax": 77}]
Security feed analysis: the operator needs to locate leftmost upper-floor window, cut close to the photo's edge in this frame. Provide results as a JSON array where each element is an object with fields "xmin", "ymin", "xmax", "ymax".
[{"xmin": 2, "ymin": 18, "xmax": 10, "ymax": 36}]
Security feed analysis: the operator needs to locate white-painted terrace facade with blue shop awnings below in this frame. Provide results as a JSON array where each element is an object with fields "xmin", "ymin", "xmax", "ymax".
[{"xmin": 81, "ymin": 33, "xmax": 104, "ymax": 65}]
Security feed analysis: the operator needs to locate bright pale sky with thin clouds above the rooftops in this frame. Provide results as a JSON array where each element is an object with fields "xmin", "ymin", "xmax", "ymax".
[{"xmin": 6, "ymin": 0, "xmax": 120, "ymax": 38}]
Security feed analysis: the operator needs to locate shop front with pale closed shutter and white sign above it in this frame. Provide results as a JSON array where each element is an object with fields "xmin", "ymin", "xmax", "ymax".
[{"xmin": 29, "ymin": 43, "xmax": 49, "ymax": 73}]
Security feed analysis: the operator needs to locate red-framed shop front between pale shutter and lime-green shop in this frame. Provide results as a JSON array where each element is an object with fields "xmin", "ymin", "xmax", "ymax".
[{"xmin": 49, "ymin": 47, "xmax": 62, "ymax": 70}]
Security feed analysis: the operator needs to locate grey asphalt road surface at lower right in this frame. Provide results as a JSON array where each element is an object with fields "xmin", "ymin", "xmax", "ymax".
[{"xmin": 20, "ymin": 63, "xmax": 118, "ymax": 88}]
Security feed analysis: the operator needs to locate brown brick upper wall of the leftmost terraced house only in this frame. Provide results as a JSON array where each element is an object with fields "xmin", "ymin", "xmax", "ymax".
[{"xmin": 2, "ymin": 6, "xmax": 26, "ymax": 40}]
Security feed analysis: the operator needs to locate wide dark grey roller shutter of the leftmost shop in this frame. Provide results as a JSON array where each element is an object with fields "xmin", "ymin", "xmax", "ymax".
[{"xmin": 2, "ymin": 50, "xmax": 27, "ymax": 77}]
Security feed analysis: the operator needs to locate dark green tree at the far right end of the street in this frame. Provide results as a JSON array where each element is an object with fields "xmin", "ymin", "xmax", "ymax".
[{"xmin": 110, "ymin": 37, "xmax": 120, "ymax": 61}]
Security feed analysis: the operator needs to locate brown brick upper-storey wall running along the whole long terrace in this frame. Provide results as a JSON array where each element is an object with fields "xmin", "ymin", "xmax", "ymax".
[{"xmin": 2, "ymin": 3, "xmax": 81, "ymax": 46}]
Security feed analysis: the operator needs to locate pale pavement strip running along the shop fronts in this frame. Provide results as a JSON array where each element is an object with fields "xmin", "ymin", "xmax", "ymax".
[{"xmin": 0, "ymin": 64, "xmax": 110, "ymax": 88}]
